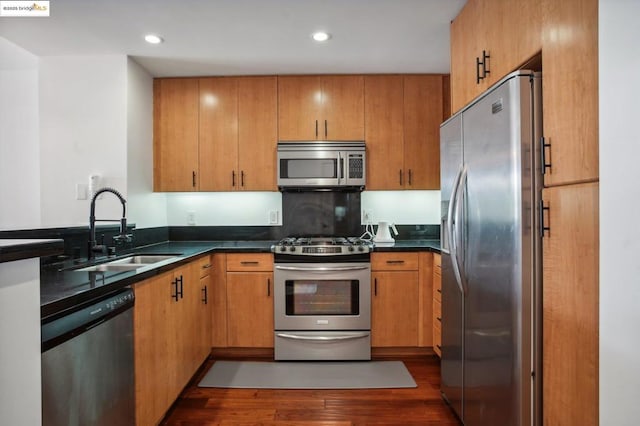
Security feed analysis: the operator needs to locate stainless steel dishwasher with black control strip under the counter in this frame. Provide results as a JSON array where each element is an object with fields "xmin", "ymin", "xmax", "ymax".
[{"xmin": 42, "ymin": 288, "xmax": 135, "ymax": 426}]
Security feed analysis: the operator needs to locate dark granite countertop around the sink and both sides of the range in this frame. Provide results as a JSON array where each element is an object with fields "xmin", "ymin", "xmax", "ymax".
[{"xmin": 40, "ymin": 240, "xmax": 440, "ymax": 318}]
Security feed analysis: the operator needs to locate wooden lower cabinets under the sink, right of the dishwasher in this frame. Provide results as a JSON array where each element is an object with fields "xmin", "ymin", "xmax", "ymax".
[{"xmin": 134, "ymin": 260, "xmax": 210, "ymax": 425}]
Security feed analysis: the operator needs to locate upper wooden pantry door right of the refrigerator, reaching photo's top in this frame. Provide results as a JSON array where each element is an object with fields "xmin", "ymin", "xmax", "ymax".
[{"xmin": 542, "ymin": 0, "xmax": 599, "ymax": 186}]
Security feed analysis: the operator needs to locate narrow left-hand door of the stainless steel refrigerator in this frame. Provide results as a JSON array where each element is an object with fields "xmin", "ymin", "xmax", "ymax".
[{"xmin": 440, "ymin": 114, "xmax": 464, "ymax": 418}]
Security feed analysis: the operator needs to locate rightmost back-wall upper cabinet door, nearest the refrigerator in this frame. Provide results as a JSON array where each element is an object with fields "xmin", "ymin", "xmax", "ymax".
[{"xmin": 404, "ymin": 75, "xmax": 443, "ymax": 189}]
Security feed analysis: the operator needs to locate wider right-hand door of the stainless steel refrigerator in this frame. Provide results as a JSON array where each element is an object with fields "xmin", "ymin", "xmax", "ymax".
[{"xmin": 460, "ymin": 77, "xmax": 533, "ymax": 426}]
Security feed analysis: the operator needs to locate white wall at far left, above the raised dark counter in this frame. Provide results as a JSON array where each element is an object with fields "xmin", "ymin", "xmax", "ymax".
[{"xmin": 0, "ymin": 37, "xmax": 40, "ymax": 229}]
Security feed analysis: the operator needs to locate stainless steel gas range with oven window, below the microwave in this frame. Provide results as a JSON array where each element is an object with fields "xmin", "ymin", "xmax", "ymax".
[{"xmin": 271, "ymin": 237, "xmax": 371, "ymax": 360}]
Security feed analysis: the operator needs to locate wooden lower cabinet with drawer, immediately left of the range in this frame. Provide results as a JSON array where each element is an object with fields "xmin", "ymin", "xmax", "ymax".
[{"xmin": 226, "ymin": 253, "xmax": 273, "ymax": 348}]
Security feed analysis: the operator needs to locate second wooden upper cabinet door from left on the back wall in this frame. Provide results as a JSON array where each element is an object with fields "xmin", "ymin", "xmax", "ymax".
[{"xmin": 199, "ymin": 77, "xmax": 239, "ymax": 191}]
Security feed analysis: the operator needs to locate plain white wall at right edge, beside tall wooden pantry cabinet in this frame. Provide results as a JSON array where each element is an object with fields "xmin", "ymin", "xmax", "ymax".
[{"xmin": 599, "ymin": 0, "xmax": 640, "ymax": 426}]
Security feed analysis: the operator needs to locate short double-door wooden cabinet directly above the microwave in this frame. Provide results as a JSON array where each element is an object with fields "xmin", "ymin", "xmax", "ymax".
[{"xmin": 278, "ymin": 75, "xmax": 364, "ymax": 141}]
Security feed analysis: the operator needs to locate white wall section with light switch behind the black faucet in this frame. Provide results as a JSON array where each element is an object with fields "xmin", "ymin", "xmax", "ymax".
[{"xmin": 39, "ymin": 55, "xmax": 127, "ymax": 227}]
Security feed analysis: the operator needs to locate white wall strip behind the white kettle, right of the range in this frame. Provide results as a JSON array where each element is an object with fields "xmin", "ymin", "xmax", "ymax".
[{"xmin": 362, "ymin": 191, "xmax": 440, "ymax": 226}]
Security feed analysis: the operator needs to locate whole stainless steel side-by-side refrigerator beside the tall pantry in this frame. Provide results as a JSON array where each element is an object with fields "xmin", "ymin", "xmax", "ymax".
[{"xmin": 440, "ymin": 70, "xmax": 542, "ymax": 426}]
